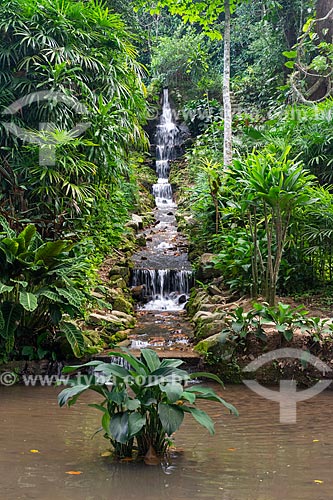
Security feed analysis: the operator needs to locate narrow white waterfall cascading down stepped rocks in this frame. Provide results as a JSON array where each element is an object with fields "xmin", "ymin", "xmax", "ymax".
[{"xmin": 132, "ymin": 89, "xmax": 192, "ymax": 311}]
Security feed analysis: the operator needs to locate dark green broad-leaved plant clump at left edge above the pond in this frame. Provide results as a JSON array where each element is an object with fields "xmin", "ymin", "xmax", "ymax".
[{"xmin": 0, "ymin": 219, "xmax": 105, "ymax": 361}]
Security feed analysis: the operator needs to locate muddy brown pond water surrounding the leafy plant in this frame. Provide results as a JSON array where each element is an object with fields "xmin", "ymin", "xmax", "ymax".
[{"xmin": 0, "ymin": 386, "xmax": 333, "ymax": 500}]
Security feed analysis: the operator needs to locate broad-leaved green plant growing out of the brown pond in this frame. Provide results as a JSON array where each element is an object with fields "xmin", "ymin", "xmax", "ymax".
[{"xmin": 58, "ymin": 349, "xmax": 238, "ymax": 458}]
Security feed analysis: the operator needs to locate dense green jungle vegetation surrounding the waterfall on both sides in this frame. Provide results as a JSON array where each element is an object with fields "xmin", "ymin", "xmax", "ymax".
[{"xmin": 0, "ymin": 0, "xmax": 333, "ymax": 360}]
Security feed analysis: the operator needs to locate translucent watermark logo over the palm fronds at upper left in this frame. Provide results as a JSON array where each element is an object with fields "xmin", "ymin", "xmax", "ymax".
[{"xmin": 2, "ymin": 90, "xmax": 91, "ymax": 166}]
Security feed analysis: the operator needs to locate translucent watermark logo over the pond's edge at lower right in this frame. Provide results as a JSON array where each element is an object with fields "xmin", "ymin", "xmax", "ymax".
[{"xmin": 243, "ymin": 348, "xmax": 332, "ymax": 424}]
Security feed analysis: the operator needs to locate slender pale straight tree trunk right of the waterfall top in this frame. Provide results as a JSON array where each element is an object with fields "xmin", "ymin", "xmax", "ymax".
[{"xmin": 223, "ymin": 0, "xmax": 232, "ymax": 168}]
